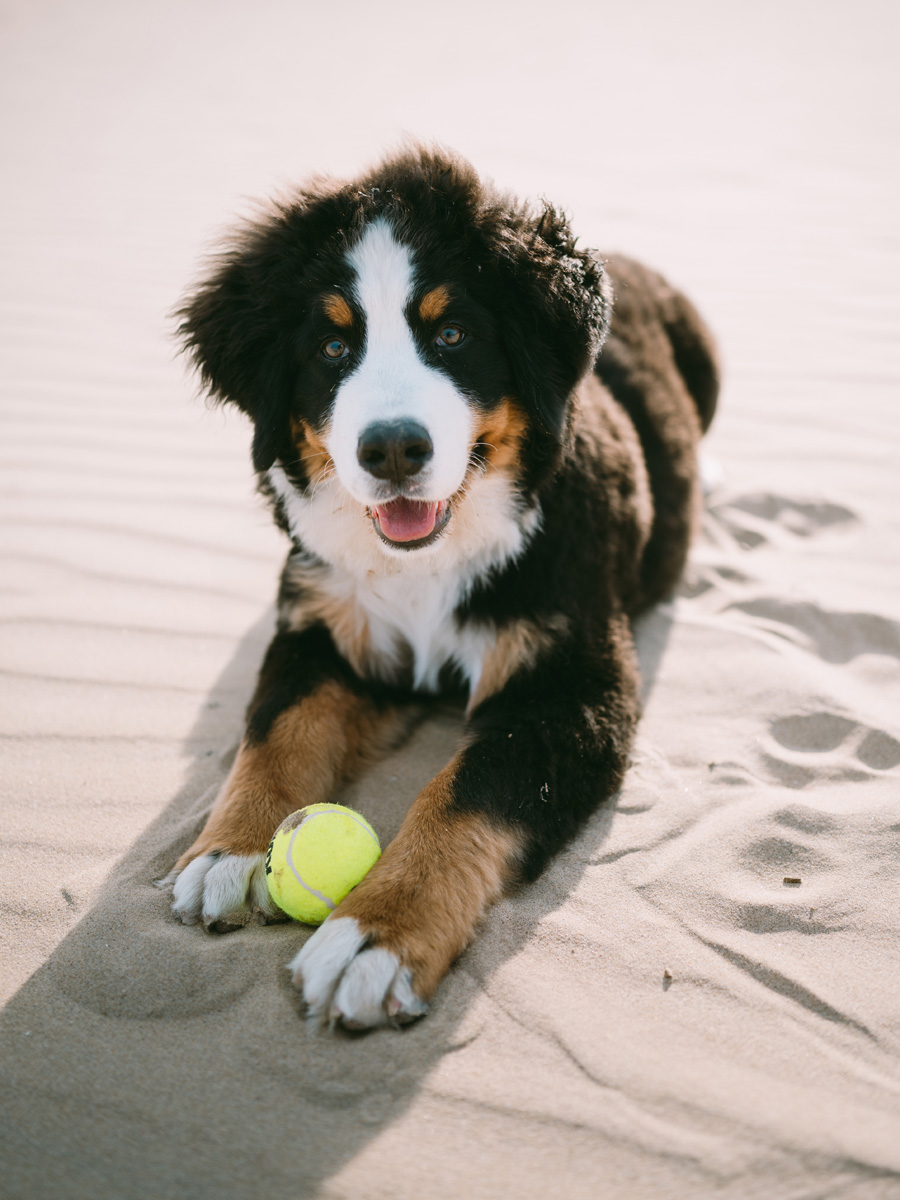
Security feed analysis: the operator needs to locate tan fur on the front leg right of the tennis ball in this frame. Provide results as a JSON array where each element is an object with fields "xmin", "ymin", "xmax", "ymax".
[{"xmin": 330, "ymin": 760, "xmax": 521, "ymax": 1000}]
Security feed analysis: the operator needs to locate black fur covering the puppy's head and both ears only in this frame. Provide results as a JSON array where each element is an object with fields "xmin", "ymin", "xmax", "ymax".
[{"xmin": 179, "ymin": 152, "xmax": 608, "ymax": 482}]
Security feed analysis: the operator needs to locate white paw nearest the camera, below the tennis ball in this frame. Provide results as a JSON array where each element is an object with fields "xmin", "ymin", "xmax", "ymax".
[{"xmin": 288, "ymin": 917, "xmax": 428, "ymax": 1030}]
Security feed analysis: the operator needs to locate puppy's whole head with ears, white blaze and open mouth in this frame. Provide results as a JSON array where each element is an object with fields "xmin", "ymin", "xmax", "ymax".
[{"xmin": 180, "ymin": 150, "xmax": 608, "ymax": 557}]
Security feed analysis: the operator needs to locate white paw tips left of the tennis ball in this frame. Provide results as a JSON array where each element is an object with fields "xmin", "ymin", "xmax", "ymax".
[{"xmin": 162, "ymin": 853, "xmax": 278, "ymax": 928}]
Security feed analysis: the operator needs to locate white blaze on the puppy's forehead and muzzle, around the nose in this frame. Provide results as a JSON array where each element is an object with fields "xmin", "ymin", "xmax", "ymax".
[{"xmin": 325, "ymin": 220, "xmax": 473, "ymax": 505}]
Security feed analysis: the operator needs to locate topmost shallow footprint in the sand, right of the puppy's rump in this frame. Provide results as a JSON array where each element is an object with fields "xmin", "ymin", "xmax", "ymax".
[{"xmin": 707, "ymin": 492, "xmax": 858, "ymax": 550}]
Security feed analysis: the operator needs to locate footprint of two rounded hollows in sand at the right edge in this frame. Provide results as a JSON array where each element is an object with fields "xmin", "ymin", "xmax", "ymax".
[{"xmin": 760, "ymin": 712, "xmax": 900, "ymax": 788}]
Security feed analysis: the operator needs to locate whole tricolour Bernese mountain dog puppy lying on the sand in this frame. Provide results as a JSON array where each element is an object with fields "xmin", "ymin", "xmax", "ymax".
[{"xmin": 170, "ymin": 149, "xmax": 718, "ymax": 1028}]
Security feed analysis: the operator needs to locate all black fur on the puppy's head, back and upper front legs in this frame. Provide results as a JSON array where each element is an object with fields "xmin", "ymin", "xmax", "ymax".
[{"xmin": 180, "ymin": 150, "xmax": 719, "ymax": 979}]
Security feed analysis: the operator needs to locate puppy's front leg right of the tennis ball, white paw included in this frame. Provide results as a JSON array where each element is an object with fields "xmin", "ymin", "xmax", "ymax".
[{"xmin": 292, "ymin": 618, "xmax": 638, "ymax": 1028}]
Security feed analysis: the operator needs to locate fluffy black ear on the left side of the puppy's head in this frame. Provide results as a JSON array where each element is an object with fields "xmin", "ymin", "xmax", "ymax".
[{"xmin": 175, "ymin": 218, "xmax": 300, "ymax": 470}]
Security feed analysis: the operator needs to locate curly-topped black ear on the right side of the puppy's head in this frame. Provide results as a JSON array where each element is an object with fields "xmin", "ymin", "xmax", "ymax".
[{"xmin": 497, "ymin": 204, "xmax": 612, "ymax": 443}]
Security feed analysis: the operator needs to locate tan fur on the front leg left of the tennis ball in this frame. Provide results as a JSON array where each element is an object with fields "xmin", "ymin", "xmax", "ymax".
[{"xmin": 175, "ymin": 682, "xmax": 409, "ymax": 871}]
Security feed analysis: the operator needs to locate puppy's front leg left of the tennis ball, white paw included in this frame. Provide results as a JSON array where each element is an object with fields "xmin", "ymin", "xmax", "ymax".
[{"xmin": 166, "ymin": 626, "xmax": 407, "ymax": 928}]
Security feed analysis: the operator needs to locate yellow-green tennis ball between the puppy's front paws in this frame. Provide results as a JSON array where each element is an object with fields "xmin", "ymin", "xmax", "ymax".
[{"xmin": 265, "ymin": 804, "xmax": 382, "ymax": 925}]
